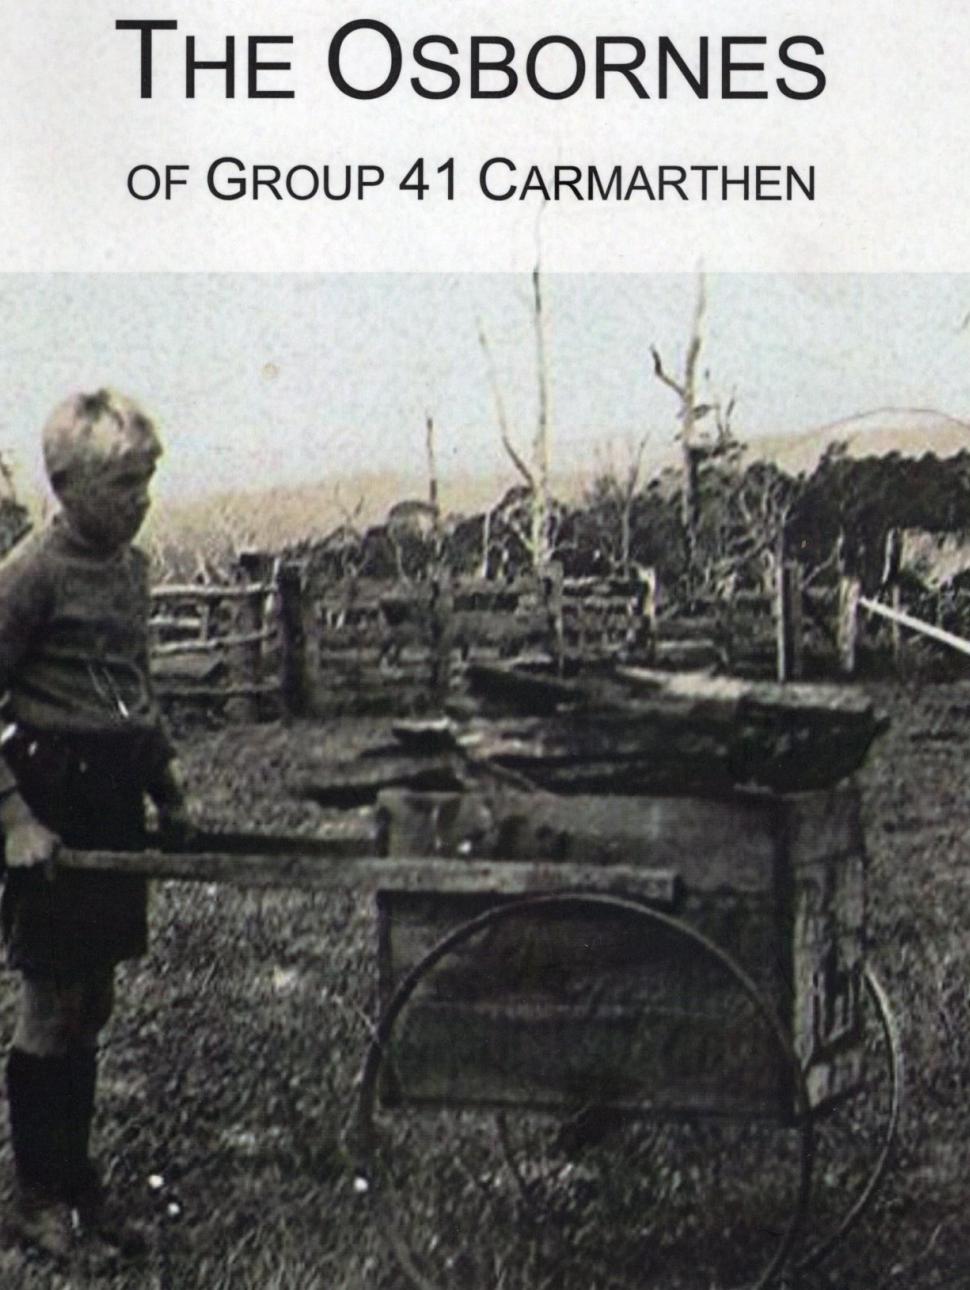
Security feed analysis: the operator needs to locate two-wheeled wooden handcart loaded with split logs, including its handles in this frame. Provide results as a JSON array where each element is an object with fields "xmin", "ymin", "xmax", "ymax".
[{"xmin": 54, "ymin": 677, "xmax": 900, "ymax": 1290}]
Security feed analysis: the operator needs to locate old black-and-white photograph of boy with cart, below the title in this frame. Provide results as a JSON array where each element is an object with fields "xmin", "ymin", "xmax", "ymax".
[{"xmin": 0, "ymin": 262, "xmax": 970, "ymax": 1290}]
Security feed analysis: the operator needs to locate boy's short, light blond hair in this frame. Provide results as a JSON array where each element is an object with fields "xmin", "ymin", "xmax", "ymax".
[{"xmin": 43, "ymin": 390, "xmax": 161, "ymax": 493}]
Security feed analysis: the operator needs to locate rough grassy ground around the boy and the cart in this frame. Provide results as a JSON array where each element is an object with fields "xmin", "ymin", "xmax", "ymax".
[{"xmin": 0, "ymin": 684, "xmax": 970, "ymax": 1290}]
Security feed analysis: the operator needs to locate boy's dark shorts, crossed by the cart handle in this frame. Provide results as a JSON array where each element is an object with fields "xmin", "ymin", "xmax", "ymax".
[{"xmin": 3, "ymin": 730, "xmax": 148, "ymax": 982}]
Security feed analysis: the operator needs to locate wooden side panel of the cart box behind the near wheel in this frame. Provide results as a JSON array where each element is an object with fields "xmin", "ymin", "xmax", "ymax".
[{"xmin": 379, "ymin": 793, "xmax": 791, "ymax": 1116}]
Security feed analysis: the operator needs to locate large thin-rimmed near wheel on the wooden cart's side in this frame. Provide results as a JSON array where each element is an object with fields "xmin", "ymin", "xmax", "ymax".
[{"xmin": 357, "ymin": 894, "xmax": 813, "ymax": 1290}]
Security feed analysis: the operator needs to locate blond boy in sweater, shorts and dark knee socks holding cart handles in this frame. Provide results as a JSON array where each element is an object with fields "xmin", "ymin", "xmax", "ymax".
[{"xmin": 0, "ymin": 390, "xmax": 186, "ymax": 1258}]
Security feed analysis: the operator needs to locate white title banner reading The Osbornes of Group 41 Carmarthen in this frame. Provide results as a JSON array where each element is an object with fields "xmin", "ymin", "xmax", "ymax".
[{"xmin": 0, "ymin": 0, "xmax": 970, "ymax": 272}]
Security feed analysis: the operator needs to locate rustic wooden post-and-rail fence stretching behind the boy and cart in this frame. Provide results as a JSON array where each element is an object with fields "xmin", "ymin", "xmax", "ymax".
[{"xmin": 145, "ymin": 559, "xmax": 970, "ymax": 720}]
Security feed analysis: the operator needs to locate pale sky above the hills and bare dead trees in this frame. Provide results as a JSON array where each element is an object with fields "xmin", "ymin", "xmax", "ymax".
[{"xmin": 0, "ymin": 273, "xmax": 970, "ymax": 501}]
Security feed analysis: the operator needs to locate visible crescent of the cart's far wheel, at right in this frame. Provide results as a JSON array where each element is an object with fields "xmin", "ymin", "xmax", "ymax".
[{"xmin": 795, "ymin": 968, "xmax": 903, "ymax": 1272}]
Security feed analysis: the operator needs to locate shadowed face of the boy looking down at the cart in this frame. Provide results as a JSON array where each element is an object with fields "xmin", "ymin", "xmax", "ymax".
[{"xmin": 59, "ymin": 458, "xmax": 155, "ymax": 550}]
